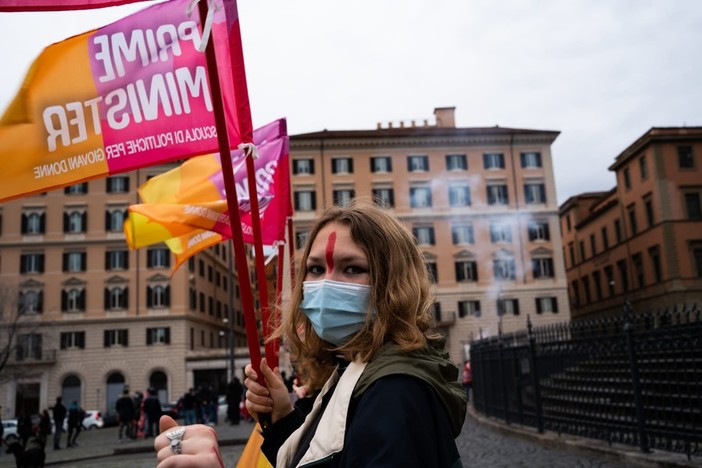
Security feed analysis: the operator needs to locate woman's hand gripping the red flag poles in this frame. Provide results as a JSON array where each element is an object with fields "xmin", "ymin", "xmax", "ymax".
[{"xmin": 244, "ymin": 359, "xmax": 294, "ymax": 424}]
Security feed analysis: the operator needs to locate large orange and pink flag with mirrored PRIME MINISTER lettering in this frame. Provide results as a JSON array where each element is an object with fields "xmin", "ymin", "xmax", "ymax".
[{"xmin": 0, "ymin": 0, "xmax": 252, "ymax": 201}]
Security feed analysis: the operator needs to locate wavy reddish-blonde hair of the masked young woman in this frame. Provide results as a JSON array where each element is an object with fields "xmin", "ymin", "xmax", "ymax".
[{"xmin": 271, "ymin": 200, "xmax": 442, "ymax": 389}]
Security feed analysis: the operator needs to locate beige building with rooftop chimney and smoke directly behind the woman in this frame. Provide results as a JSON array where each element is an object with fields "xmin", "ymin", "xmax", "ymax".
[{"xmin": 290, "ymin": 107, "xmax": 570, "ymax": 363}]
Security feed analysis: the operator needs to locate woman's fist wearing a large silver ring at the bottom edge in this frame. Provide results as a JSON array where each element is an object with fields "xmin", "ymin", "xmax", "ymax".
[{"xmin": 154, "ymin": 416, "xmax": 224, "ymax": 468}]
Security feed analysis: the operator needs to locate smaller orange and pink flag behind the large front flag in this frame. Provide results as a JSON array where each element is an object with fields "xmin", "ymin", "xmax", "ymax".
[{"xmin": 124, "ymin": 119, "xmax": 291, "ymax": 268}]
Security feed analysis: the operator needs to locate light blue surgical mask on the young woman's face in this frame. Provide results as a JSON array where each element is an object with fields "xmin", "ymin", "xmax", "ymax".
[{"xmin": 300, "ymin": 280, "xmax": 376, "ymax": 346}]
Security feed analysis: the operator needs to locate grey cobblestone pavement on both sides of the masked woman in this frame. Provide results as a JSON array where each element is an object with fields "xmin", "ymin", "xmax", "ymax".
[{"xmin": 0, "ymin": 411, "xmax": 699, "ymax": 468}]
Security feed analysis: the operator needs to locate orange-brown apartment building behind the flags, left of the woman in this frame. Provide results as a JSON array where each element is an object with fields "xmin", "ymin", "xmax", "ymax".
[{"xmin": 0, "ymin": 165, "xmax": 253, "ymax": 418}]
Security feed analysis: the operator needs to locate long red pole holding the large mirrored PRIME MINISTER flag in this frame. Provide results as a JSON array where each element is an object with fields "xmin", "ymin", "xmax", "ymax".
[{"xmin": 198, "ymin": 1, "xmax": 265, "ymax": 386}]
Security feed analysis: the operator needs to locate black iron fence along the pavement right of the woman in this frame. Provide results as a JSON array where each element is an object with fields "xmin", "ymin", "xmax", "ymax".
[{"xmin": 470, "ymin": 304, "xmax": 702, "ymax": 458}]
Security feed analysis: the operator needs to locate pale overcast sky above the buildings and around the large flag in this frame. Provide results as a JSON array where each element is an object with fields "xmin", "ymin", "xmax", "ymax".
[{"xmin": 0, "ymin": 0, "xmax": 702, "ymax": 203}]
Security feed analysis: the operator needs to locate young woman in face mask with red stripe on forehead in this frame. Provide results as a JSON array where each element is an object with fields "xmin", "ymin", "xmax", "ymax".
[{"xmin": 155, "ymin": 203, "xmax": 466, "ymax": 468}]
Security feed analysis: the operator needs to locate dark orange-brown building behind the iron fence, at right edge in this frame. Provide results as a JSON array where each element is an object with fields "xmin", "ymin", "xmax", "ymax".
[{"xmin": 560, "ymin": 127, "xmax": 702, "ymax": 319}]
